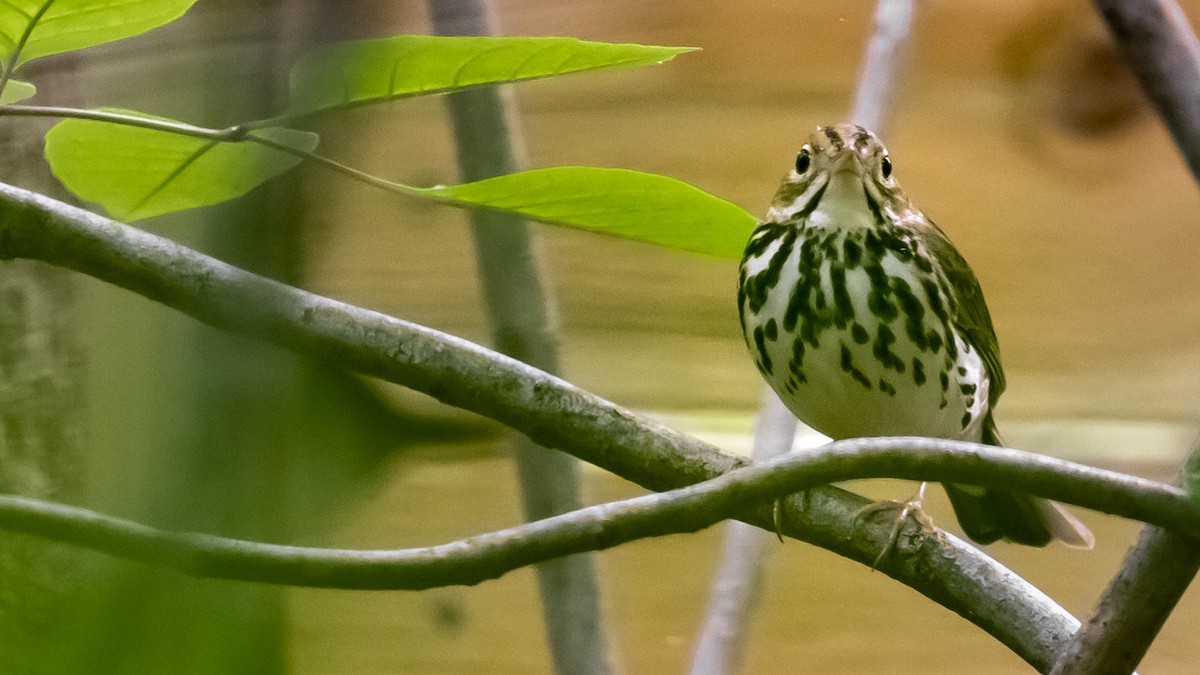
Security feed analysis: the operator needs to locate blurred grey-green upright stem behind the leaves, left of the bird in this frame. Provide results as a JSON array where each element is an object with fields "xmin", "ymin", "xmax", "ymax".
[{"xmin": 430, "ymin": 0, "xmax": 610, "ymax": 674}]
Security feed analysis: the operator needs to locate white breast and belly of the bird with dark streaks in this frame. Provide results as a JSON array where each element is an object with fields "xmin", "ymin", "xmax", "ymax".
[{"xmin": 742, "ymin": 222, "xmax": 988, "ymax": 441}]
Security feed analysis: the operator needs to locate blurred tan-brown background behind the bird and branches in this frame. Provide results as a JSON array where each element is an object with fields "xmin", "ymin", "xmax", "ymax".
[{"xmin": 70, "ymin": 0, "xmax": 1200, "ymax": 674}]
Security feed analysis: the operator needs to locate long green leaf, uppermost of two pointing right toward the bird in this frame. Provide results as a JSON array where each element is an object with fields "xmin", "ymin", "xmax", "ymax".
[{"xmin": 292, "ymin": 35, "xmax": 692, "ymax": 114}]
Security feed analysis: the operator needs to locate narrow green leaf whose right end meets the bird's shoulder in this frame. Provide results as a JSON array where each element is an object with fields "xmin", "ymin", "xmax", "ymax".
[{"xmin": 418, "ymin": 167, "xmax": 757, "ymax": 259}]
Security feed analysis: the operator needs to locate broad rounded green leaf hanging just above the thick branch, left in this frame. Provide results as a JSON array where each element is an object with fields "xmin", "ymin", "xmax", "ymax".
[{"xmin": 46, "ymin": 113, "xmax": 318, "ymax": 221}]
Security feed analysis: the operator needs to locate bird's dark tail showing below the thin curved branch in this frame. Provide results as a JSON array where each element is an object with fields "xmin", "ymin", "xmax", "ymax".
[{"xmin": 946, "ymin": 416, "xmax": 1096, "ymax": 549}]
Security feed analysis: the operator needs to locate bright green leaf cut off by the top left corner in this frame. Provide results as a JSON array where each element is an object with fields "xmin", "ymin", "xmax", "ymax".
[{"xmin": 0, "ymin": 0, "xmax": 196, "ymax": 66}]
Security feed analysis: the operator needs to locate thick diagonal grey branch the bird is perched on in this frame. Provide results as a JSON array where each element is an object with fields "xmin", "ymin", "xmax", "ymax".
[{"xmin": 0, "ymin": 185, "xmax": 1099, "ymax": 665}]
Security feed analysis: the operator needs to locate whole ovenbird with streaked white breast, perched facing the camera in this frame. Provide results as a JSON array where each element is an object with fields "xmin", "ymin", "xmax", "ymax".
[{"xmin": 738, "ymin": 124, "xmax": 1093, "ymax": 548}]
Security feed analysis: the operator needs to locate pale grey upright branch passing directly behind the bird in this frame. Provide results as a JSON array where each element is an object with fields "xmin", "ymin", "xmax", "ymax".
[{"xmin": 691, "ymin": 0, "xmax": 913, "ymax": 675}]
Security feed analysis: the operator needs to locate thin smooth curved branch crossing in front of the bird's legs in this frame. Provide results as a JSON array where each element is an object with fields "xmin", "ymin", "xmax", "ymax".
[{"xmin": 0, "ymin": 437, "xmax": 1200, "ymax": 588}]
